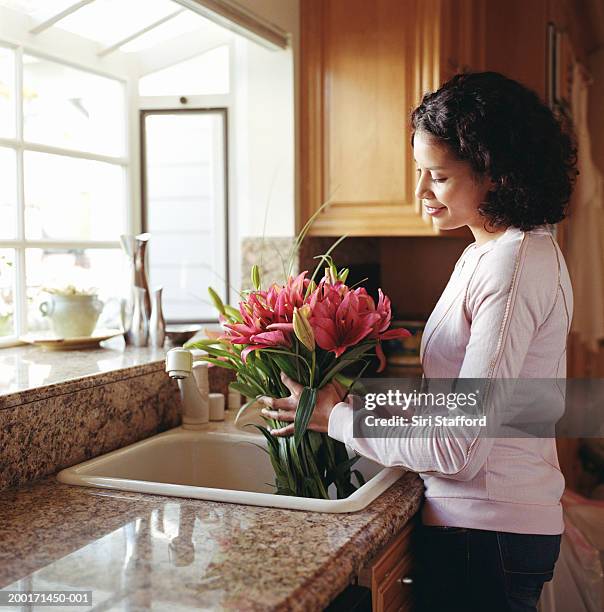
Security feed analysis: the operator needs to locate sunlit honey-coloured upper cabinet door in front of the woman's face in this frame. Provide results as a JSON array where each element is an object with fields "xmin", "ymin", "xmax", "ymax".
[{"xmin": 299, "ymin": 0, "xmax": 440, "ymax": 236}]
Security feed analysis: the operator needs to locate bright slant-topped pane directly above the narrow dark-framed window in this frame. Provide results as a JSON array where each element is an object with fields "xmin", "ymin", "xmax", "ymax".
[{"xmin": 138, "ymin": 45, "xmax": 229, "ymax": 96}]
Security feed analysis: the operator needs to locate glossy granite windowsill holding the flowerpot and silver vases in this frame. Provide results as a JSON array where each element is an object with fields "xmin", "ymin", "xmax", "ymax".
[{"xmin": 0, "ymin": 337, "xmax": 177, "ymax": 409}]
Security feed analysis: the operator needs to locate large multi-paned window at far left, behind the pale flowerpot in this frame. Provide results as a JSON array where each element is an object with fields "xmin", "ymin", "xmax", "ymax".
[{"xmin": 0, "ymin": 46, "xmax": 128, "ymax": 343}]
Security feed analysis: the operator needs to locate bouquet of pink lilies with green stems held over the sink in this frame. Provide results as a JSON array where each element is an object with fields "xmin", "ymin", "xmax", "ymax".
[{"xmin": 186, "ymin": 245, "xmax": 410, "ymax": 499}]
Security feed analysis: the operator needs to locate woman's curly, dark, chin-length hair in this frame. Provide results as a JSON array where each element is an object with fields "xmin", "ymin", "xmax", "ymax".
[{"xmin": 411, "ymin": 72, "xmax": 577, "ymax": 231}]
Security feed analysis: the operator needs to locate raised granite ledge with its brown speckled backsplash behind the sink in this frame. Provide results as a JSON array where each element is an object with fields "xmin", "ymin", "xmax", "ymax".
[{"xmin": 0, "ymin": 338, "xmax": 232, "ymax": 490}]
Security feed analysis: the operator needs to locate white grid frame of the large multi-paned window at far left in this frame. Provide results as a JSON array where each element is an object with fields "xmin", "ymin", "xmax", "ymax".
[{"xmin": 0, "ymin": 38, "xmax": 137, "ymax": 348}]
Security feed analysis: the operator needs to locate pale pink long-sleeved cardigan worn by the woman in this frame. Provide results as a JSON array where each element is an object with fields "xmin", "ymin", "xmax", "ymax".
[{"xmin": 329, "ymin": 226, "xmax": 573, "ymax": 534}]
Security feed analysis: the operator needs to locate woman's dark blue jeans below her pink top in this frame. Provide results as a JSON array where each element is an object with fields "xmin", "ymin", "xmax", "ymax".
[{"xmin": 415, "ymin": 526, "xmax": 561, "ymax": 612}]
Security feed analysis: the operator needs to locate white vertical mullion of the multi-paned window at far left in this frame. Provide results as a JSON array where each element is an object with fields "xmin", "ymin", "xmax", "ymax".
[{"xmin": 14, "ymin": 47, "xmax": 27, "ymax": 336}]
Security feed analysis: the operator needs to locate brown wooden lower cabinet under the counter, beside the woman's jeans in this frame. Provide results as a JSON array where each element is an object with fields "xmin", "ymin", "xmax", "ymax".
[{"xmin": 359, "ymin": 520, "xmax": 415, "ymax": 612}]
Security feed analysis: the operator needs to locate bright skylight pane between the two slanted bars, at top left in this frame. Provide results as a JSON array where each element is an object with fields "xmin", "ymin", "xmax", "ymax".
[{"xmin": 57, "ymin": 0, "xmax": 181, "ymax": 46}]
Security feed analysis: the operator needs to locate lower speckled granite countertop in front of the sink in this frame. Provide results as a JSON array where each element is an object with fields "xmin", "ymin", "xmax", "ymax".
[{"xmin": 0, "ymin": 473, "xmax": 423, "ymax": 611}]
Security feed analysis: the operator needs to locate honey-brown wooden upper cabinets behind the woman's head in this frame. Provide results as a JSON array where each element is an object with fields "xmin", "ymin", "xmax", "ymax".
[{"xmin": 298, "ymin": 0, "xmax": 547, "ymax": 236}]
